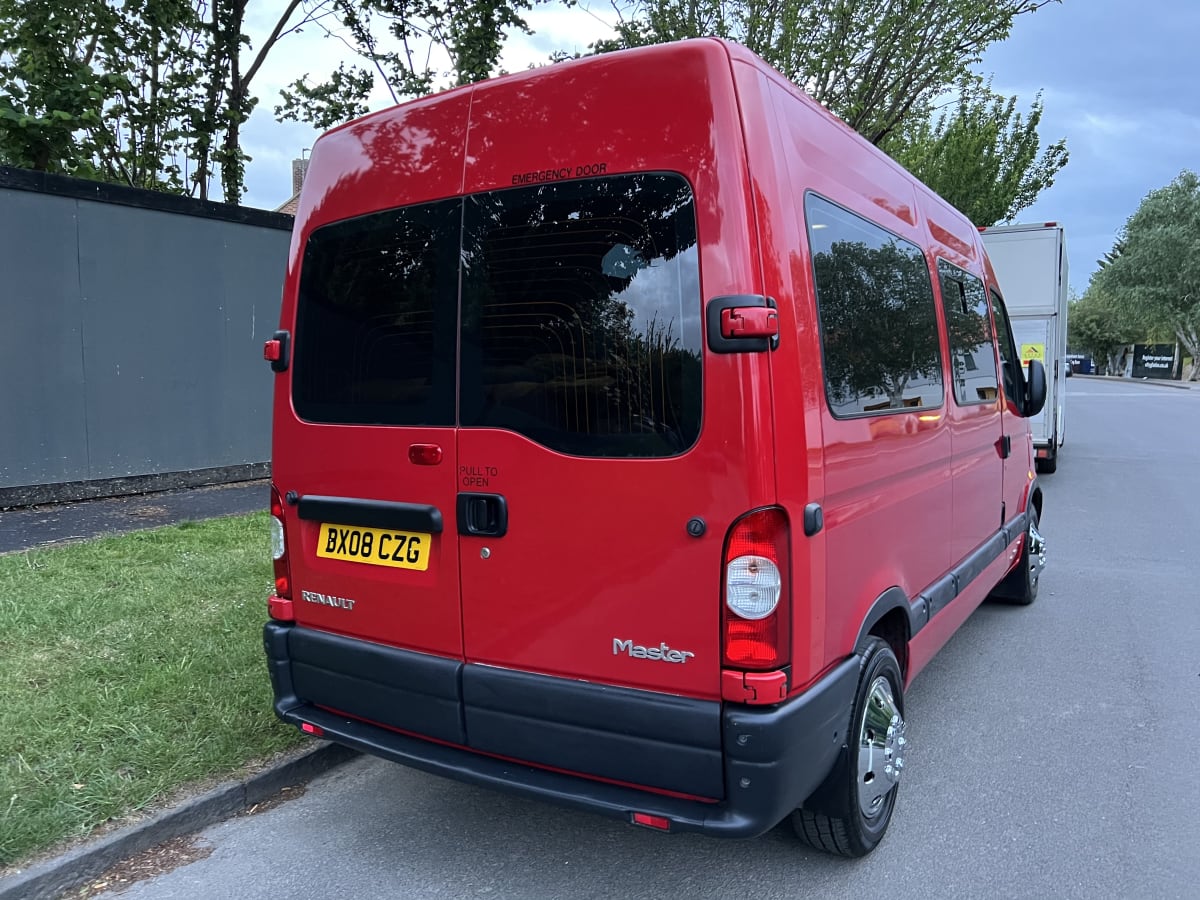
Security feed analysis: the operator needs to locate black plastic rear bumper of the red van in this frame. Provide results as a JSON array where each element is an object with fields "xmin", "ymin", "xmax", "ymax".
[{"xmin": 263, "ymin": 622, "xmax": 858, "ymax": 838}]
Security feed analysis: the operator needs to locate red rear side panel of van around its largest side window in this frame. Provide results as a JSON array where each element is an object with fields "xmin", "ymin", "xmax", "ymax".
[{"xmin": 764, "ymin": 76, "xmax": 952, "ymax": 683}]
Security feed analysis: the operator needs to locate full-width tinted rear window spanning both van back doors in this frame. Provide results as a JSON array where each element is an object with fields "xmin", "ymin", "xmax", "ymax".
[{"xmin": 293, "ymin": 173, "xmax": 702, "ymax": 457}]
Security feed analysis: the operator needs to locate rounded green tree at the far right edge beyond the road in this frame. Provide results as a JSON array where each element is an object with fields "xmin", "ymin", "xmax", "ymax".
[{"xmin": 1090, "ymin": 170, "xmax": 1200, "ymax": 380}]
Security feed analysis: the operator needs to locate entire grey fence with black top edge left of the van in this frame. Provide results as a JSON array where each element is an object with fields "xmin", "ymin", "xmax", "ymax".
[{"xmin": 0, "ymin": 167, "xmax": 290, "ymax": 506}]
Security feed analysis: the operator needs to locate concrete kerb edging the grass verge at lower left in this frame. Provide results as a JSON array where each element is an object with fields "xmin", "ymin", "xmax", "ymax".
[{"xmin": 0, "ymin": 744, "xmax": 359, "ymax": 900}]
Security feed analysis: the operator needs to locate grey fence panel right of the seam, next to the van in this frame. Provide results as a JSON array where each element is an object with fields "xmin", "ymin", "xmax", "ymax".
[{"xmin": 79, "ymin": 204, "xmax": 287, "ymax": 478}]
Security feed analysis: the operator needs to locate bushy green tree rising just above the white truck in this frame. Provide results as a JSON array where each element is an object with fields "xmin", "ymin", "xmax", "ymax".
[{"xmin": 883, "ymin": 76, "xmax": 1068, "ymax": 226}]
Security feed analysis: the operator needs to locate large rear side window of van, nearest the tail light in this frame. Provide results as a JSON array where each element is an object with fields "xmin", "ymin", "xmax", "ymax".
[{"xmin": 804, "ymin": 193, "xmax": 944, "ymax": 419}]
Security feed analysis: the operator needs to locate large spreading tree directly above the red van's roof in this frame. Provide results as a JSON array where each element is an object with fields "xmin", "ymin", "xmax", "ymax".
[{"xmin": 594, "ymin": 0, "xmax": 1061, "ymax": 144}]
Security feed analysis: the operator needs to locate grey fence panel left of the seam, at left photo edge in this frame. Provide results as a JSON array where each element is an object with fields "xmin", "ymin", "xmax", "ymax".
[{"xmin": 0, "ymin": 191, "xmax": 88, "ymax": 486}]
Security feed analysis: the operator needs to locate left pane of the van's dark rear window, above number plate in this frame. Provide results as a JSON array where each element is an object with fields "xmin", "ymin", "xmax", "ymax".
[{"xmin": 292, "ymin": 199, "xmax": 462, "ymax": 425}]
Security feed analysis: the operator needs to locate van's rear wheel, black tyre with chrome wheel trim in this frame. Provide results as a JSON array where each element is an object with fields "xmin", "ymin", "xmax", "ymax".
[{"xmin": 792, "ymin": 637, "xmax": 907, "ymax": 857}]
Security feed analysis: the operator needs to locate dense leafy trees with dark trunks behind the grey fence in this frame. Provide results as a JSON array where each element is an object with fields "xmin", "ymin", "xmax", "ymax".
[{"xmin": 0, "ymin": 0, "xmax": 319, "ymax": 203}]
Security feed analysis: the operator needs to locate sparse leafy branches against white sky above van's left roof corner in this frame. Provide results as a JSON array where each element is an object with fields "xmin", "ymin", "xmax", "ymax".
[{"xmin": 275, "ymin": 0, "xmax": 542, "ymax": 128}]
